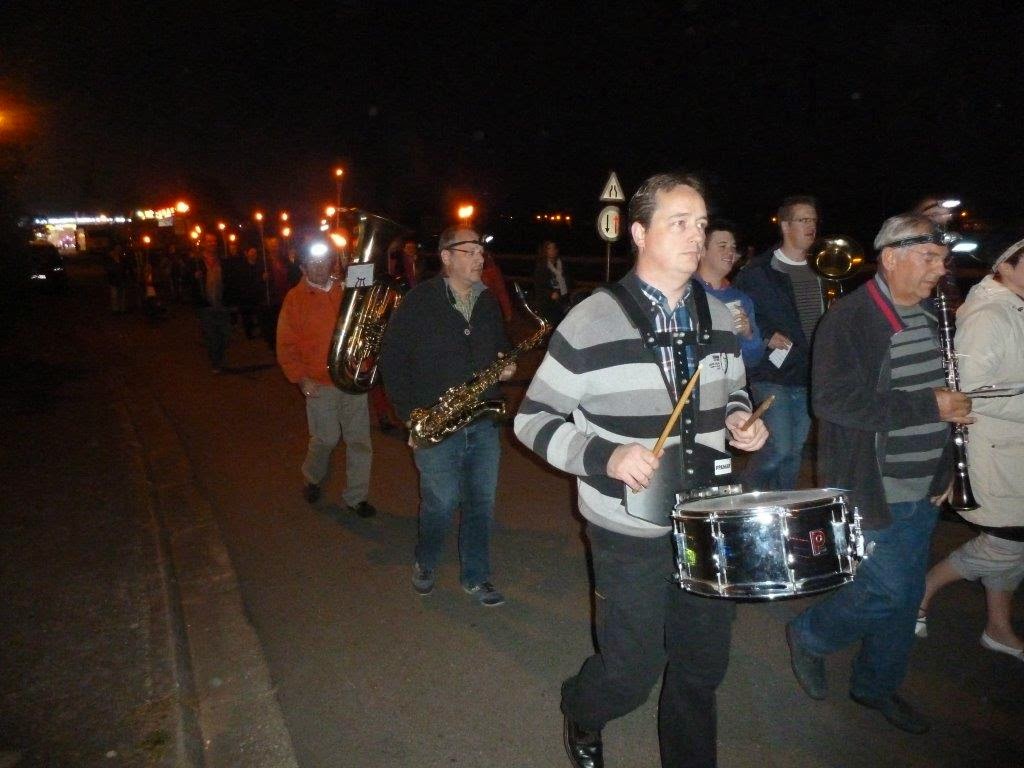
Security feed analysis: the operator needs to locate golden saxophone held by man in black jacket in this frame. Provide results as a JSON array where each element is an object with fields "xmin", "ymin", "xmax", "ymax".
[{"xmin": 409, "ymin": 284, "xmax": 551, "ymax": 447}]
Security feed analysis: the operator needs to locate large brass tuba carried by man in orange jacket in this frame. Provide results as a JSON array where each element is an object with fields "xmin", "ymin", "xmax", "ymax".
[{"xmin": 328, "ymin": 208, "xmax": 409, "ymax": 392}]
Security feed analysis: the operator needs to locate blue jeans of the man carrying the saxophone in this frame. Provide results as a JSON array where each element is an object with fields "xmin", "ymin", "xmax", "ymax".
[{"xmin": 413, "ymin": 419, "xmax": 501, "ymax": 587}]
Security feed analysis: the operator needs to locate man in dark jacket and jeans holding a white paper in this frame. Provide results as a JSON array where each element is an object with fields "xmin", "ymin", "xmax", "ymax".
[{"xmin": 735, "ymin": 196, "xmax": 823, "ymax": 490}]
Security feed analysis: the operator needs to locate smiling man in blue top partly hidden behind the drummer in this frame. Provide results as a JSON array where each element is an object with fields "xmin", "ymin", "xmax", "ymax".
[{"xmin": 696, "ymin": 219, "xmax": 765, "ymax": 369}]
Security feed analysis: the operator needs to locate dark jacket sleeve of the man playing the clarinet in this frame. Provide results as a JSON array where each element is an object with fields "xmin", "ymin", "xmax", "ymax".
[{"xmin": 811, "ymin": 305, "xmax": 939, "ymax": 432}]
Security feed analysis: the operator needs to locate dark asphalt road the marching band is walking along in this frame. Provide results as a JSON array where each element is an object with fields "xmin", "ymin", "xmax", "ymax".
[{"xmin": 0, "ymin": 260, "xmax": 1024, "ymax": 768}]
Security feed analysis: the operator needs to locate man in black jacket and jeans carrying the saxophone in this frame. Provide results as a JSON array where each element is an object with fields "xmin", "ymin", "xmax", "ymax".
[{"xmin": 380, "ymin": 227, "xmax": 515, "ymax": 606}]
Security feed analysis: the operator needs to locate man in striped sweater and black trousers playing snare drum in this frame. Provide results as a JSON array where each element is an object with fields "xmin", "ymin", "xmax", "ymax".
[{"xmin": 515, "ymin": 174, "xmax": 768, "ymax": 768}]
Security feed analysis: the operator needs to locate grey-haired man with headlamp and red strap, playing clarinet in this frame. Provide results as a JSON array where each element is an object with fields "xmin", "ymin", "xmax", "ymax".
[{"xmin": 786, "ymin": 214, "xmax": 974, "ymax": 733}]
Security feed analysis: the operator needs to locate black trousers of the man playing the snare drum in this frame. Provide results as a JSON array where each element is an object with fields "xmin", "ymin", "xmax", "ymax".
[{"xmin": 561, "ymin": 525, "xmax": 736, "ymax": 768}]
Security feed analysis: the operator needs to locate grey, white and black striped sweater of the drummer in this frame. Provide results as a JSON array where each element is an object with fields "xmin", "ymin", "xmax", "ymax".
[{"xmin": 514, "ymin": 272, "xmax": 751, "ymax": 538}]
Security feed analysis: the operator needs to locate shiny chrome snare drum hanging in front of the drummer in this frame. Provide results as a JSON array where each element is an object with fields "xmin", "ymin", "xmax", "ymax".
[{"xmin": 672, "ymin": 488, "xmax": 863, "ymax": 600}]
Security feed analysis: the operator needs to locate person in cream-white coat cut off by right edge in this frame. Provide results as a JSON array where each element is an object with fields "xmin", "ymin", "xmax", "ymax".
[{"xmin": 916, "ymin": 240, "xmax": 1024, "ymax": 662}]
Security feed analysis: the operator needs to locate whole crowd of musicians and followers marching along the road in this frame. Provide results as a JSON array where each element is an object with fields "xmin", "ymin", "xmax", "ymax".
[{"xmin": 97, "ymin": 173, "xmax": 1024, "ymax": 768}]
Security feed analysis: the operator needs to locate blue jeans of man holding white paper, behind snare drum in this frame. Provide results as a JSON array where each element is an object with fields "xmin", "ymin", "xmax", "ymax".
[{"xmin": 742, "ymin": 381, "xmax": 811, "ymax": 490}]
